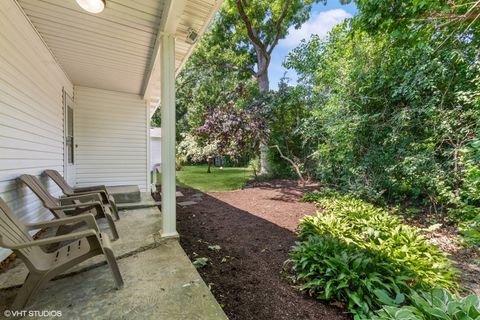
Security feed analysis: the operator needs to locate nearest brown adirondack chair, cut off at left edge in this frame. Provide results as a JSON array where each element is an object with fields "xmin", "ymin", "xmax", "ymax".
[{"xmin": 0, "ymin": 198, "xmax": 123, "ymax": 310}]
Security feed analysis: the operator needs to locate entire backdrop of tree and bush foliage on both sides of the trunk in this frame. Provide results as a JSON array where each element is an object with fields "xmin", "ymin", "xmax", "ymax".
[{"xmin": 170, "ymin": 0, "xmax": 480, "ymax": 232}]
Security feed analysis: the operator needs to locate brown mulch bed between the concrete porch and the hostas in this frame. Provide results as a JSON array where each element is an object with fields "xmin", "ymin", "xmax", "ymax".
[{"xmin": 168, "ymin": 181, "xmax": 349, "ymax": 320}]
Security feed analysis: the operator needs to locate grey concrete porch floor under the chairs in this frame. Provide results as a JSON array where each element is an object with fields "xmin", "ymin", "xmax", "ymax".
[{"xmin": 0, "ymin": 207, "xmax": 227, "ymax": 320}]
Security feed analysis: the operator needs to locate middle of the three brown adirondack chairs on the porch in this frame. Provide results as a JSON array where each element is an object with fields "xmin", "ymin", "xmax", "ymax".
[{"xmin": 18, "ymin": 174, "xmax": 118, "ymax": 240}]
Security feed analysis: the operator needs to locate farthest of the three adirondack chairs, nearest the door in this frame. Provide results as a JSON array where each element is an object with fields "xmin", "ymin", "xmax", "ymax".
[{"xmin": 43, "ymin": 170, "xmax": 120, "ymax": 220}]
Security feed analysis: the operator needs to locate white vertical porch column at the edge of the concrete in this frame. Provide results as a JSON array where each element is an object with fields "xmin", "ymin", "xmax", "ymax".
[{"xmin": 160, "ymin": 33, "xmax": 178, "ymax": 237}]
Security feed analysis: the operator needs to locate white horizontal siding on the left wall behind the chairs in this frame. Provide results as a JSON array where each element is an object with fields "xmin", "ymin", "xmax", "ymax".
[{"xmin": 0, "ymin": 0, "xmax": 73, "ymax": 260}]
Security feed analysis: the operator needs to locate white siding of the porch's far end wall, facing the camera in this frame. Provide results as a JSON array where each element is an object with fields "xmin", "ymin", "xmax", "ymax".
[{"xmin": 74, "ymin": 86, "xmax": 149, "ymax": 191}]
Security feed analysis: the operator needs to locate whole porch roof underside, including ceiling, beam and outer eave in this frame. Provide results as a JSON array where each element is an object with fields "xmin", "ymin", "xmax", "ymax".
[{"xmin": 17, "ymin": 0, "xmax": 222, "ymax": 115}]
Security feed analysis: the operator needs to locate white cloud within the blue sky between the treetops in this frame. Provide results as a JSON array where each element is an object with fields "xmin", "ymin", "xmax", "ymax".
[{"xmin": 279, "ymin": 9, "xmax": 352, "ymax": 48}]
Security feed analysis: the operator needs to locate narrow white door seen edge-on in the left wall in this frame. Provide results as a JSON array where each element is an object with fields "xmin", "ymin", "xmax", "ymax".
[{"xmin": 63, "ymin": 91, "xmax": 76, "ymax": 186}]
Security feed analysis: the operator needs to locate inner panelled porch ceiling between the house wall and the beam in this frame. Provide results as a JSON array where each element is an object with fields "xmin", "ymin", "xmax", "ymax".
[{"xmin": 18, "ymin": 0, "xmax": 168, "ymax": 94}]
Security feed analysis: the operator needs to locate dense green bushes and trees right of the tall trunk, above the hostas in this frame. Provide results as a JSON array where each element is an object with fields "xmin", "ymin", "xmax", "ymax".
[{"xmin": 258, "ymin": 0, "xmax": 480, "ymax": 250}]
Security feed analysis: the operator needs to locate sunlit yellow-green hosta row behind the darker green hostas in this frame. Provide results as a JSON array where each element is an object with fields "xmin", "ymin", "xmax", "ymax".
[{"xmin": 299, "ymin": 193, "xmax": 456, "ymax": 289}]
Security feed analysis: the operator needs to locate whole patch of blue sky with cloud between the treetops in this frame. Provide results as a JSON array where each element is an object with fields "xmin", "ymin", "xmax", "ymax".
[{"xmin": 268, "ymin": 0, "xmax": 357, "ymax": 90}]
